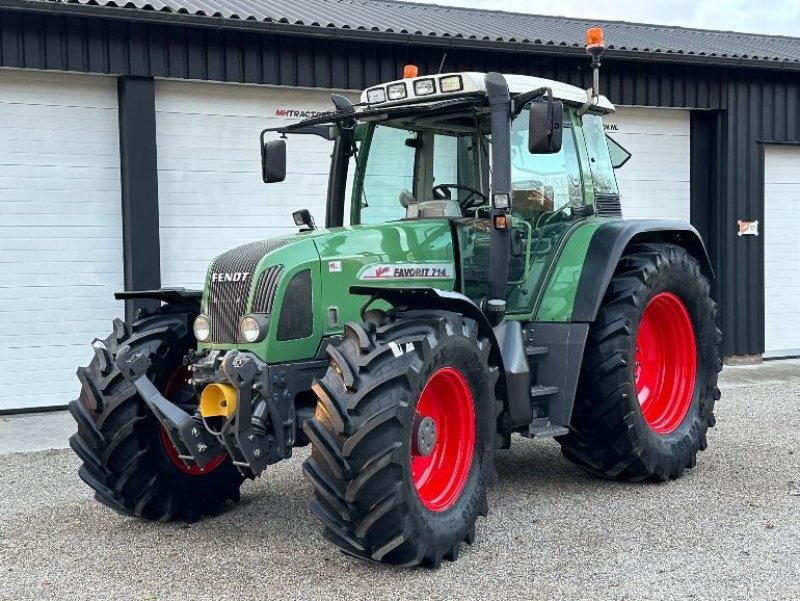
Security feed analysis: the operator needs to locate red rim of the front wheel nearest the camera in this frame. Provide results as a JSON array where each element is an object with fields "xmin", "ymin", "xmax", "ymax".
[{"xmin": 411, "ymin": 367, "xmax": 475, "ymax": 511}]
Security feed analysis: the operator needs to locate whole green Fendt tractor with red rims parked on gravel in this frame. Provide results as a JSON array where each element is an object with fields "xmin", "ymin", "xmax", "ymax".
[{"xmin": 70, "ymin": 31, "xmax": 722, "ymax": 567}]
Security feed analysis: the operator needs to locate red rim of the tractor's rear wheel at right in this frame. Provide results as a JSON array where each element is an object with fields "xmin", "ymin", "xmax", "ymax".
[{"xmin": 634, "ymin": 292, "xmax": 697, "ymax": 434}]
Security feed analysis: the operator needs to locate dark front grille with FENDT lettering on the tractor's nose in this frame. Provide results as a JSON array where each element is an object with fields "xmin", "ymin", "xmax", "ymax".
[{"xmin": 208, "ymin": 240, "xmax": 287, "ymax": 343}]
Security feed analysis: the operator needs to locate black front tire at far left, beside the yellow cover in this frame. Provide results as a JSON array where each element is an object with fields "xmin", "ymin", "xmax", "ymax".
[{"xmin": 69, "ymin": 306, "xmax": 242, "ymax": 521}]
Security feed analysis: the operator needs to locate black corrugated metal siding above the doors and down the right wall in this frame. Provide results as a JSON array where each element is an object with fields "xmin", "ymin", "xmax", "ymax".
[{"xmin": 0, "ymin": 10, "xmax": 800, "ymax": 356}]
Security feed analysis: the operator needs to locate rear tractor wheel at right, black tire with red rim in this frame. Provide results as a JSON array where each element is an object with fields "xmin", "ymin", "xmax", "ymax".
[{"xmin": 559, "ymin": 244, "xmax": 722, "ymax": 482}]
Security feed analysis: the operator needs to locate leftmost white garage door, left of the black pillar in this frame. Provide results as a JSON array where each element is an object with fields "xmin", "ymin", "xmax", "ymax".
[{"xmin": 0, "ymin": 70, "xmax": 123, "ymax": 410}]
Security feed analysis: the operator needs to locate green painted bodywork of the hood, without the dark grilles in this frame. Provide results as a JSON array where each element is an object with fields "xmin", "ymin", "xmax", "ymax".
[{"xmin": 198, "ymin": 219, "xmax": 456, "ymax": 364}]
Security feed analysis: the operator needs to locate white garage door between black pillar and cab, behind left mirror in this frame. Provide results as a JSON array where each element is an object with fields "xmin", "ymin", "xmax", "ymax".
[{"xmin": 156, "ymin": 81, "xmax": 346, "ymax": 288}]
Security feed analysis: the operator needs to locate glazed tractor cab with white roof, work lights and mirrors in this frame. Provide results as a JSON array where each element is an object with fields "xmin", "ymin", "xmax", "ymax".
[{"xmin": 262, "ymin": 67, "xmax": 629, "ymax": 314}]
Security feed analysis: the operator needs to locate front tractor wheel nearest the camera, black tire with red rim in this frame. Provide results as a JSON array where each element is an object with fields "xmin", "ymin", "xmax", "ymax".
[{"xmin": 303, "ymin": 310, "xmax": 500, "ymax": 568}]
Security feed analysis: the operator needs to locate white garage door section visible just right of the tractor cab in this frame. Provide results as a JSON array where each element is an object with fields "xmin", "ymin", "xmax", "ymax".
[{"xmin": 605, "ymin": 107, "xmax": 690, "ymax": 221}]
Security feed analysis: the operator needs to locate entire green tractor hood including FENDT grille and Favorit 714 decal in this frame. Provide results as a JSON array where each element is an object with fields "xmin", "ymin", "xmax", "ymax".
[{"xmin": 201, "ymin": 219, "xmax": 456, "ymax": 363}]
